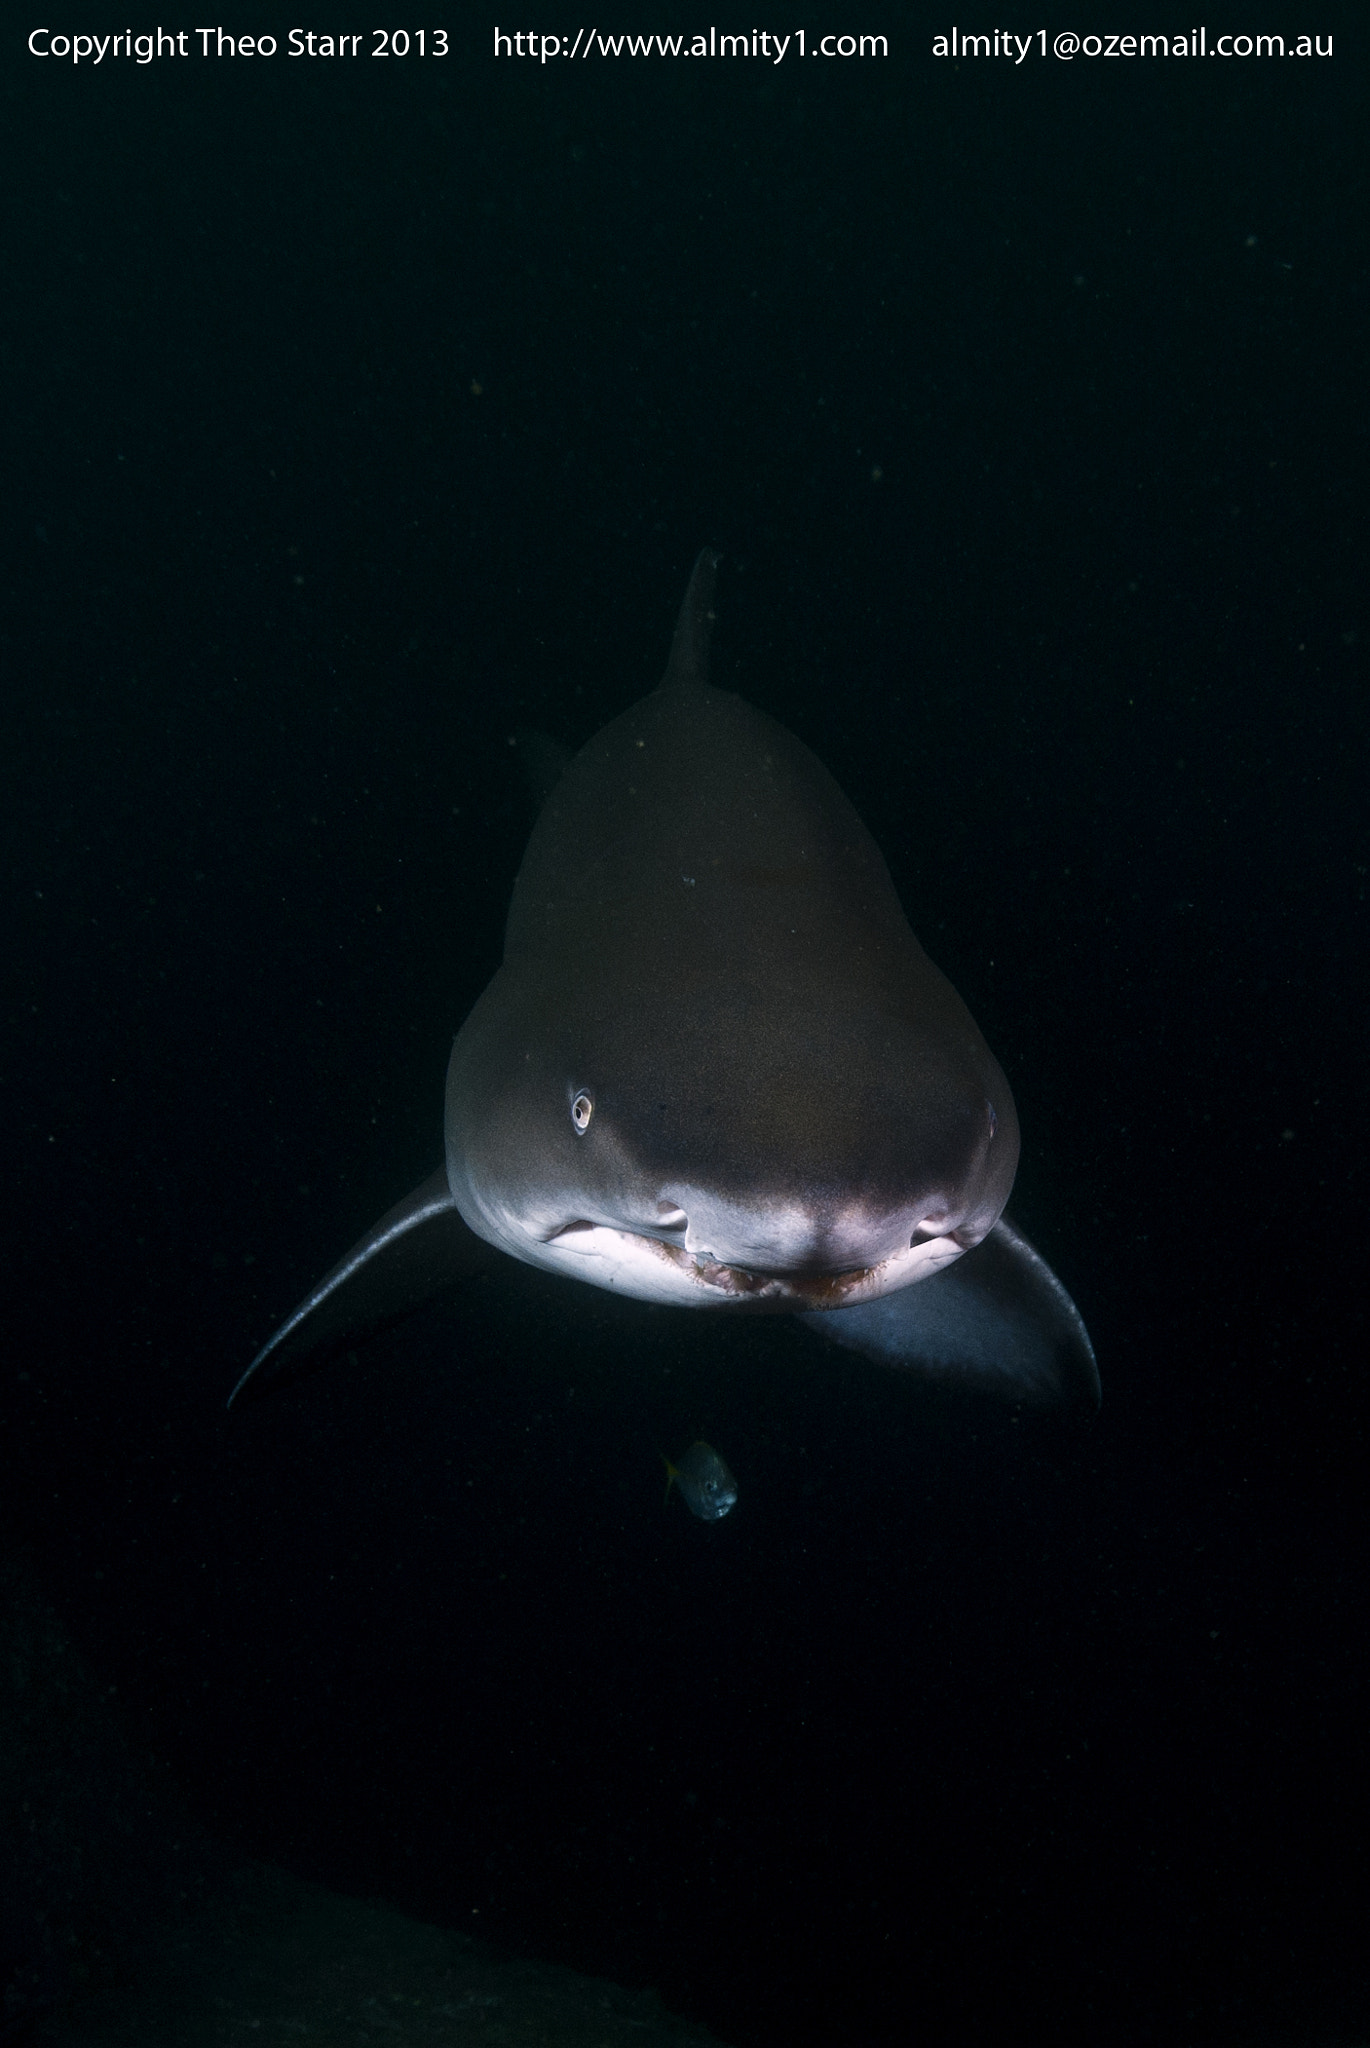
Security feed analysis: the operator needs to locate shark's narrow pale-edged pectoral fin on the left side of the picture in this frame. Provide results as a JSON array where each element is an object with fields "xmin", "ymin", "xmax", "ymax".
[{"xmin": 229, "ymin": 1167, "xmax": 496, "ymax": 1407}]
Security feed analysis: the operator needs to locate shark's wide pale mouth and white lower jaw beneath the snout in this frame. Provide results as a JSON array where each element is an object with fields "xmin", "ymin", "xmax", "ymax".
[{"xmin": 524, "ymin": 1223, "xmax": 967, "ymax": 1313}]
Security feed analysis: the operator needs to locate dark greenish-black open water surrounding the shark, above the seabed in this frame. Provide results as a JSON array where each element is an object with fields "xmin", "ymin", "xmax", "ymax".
[{"xmin": 0, "ymin": 8, "xmax": 1370, "ymax": 2048}]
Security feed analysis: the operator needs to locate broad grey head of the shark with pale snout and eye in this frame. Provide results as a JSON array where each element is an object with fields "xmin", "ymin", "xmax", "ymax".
[{"xmin": 446, "ymin": 977, "xmax": 1018, "ymax": 1309}]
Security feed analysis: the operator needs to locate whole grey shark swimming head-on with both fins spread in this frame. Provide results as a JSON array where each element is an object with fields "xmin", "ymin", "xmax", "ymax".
[{"xmin": 229, "ymin": 551, "xmax": 1100, "ymax": 1405}]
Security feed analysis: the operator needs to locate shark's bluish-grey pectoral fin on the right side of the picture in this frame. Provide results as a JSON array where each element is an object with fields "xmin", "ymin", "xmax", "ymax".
[{"xmin": 799, "ymin": 1217, "xmax": 1100, "ymax": 1409}]
